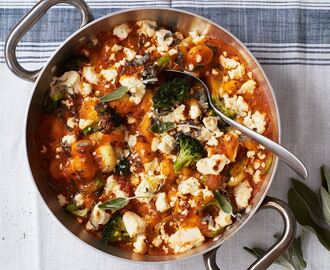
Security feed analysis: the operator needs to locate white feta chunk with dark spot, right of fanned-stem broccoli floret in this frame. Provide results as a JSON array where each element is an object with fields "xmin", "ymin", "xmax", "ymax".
[{"xmin": 196, "ymin": 154, "xmax": 230, "ymax": 175}]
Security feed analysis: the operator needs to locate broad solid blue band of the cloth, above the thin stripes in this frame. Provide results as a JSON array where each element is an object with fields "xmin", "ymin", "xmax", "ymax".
[{"xmin": 0, "ymin": 8, "xmax": 330, "ymax": 44}]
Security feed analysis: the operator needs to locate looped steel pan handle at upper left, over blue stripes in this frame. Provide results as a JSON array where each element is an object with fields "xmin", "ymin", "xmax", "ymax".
[{"xmin": 5, "ymin": 0, "xmax": 93, "ymax": 82}]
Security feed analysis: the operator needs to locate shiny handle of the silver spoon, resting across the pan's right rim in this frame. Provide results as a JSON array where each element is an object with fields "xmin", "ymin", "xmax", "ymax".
[{"xmin": 211, "ymin": 104, "xmax": 308, "ymax": 179}]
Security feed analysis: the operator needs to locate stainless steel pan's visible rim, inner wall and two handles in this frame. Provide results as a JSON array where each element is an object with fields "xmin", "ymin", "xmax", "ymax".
[{"xmin": 5, "ymin": 0, "xmax": 296, "ymax": 270}]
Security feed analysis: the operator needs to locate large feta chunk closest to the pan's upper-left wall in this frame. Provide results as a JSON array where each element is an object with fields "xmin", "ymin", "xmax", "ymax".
[{"xmin": 50, "ymin": 71, "xmax": 81, "ymax": 96}]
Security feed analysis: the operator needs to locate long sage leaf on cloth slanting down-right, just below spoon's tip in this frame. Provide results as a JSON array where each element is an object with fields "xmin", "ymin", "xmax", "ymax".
[{"xmin": 291, "ymin": 178, "xmax": 330, "ymax": 229}]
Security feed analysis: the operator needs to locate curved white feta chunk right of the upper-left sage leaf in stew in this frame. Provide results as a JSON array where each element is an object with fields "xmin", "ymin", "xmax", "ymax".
[{"xmin": 119, "ymin": 75, "xmax": 146, "ymax": 104}]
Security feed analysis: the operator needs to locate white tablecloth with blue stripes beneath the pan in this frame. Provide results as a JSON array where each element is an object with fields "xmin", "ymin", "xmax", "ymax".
[{"xmin": 0, "ymin": 0, "xmax": 330, "ymax": 270}]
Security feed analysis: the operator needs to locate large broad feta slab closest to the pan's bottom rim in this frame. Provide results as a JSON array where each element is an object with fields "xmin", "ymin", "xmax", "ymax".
[{"xmin": 168, "ymin": 227, "xmax": 204, "ymax": 253}]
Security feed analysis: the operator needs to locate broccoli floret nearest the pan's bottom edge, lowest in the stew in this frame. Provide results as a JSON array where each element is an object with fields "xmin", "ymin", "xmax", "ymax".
[{"xmin": 102, "ymin": 213, "xmax": 130, "ymax": 243}]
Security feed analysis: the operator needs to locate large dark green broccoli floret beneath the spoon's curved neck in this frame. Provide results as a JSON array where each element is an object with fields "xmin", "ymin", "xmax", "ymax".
[{"xmin": 153, "ymin": 78, "xmax": 190, "ymax": 109}]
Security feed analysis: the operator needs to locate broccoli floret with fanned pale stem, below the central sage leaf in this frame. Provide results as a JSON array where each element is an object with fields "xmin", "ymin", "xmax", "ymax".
[{"xmin": 174, "ymin": 134, "xmax": 206, "ymax": 173}]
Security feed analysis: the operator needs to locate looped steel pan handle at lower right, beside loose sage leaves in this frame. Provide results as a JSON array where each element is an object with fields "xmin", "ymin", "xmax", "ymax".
[{"xmin": 203, "ymin": 197, "xmax": 297, "ymax": 270}]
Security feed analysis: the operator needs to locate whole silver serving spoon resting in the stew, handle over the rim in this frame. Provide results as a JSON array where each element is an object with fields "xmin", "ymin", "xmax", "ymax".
[{"xmin": 162, "ymin": 69, "xmax": 308, "ymax": 179}]
